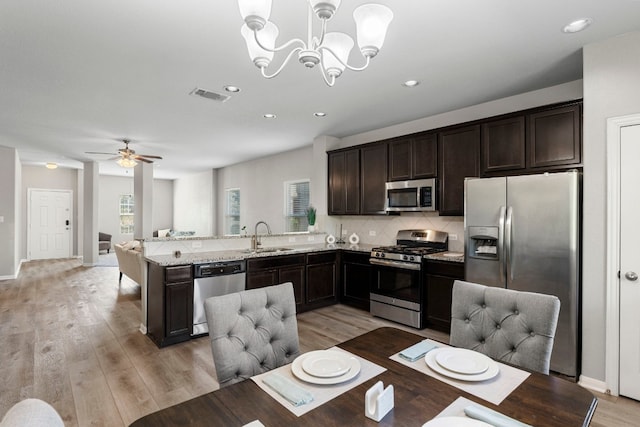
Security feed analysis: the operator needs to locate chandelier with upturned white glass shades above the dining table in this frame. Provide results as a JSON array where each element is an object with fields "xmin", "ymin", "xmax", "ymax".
[{"xmin": 238, "ymin": 0, "xmax": 393, "ymax": 86}]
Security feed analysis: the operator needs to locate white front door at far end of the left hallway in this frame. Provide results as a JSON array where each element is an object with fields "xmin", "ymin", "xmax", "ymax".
[{"xmin": 27, "ymin": 189, "xmax": 72, "ymax": 260}]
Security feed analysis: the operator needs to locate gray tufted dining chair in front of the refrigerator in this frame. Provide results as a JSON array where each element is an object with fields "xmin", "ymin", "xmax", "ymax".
[{"xmin": 449, "ymin": 280, "xmax": 560, "ymax": 374}]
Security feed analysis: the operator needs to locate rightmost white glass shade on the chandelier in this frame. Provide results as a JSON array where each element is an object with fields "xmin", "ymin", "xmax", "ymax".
[{"xmin": 353, "ymin": 3, "xmax": 393, "ymax": 57}]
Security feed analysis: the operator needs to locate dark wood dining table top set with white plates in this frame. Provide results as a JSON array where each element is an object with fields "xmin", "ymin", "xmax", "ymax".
[{"xmin": 131, "ymin": 327, "xmax": 597, "ymax": 427}]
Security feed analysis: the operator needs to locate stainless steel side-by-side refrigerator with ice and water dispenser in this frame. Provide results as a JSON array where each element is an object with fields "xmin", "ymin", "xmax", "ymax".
[{"xmin": 464, "ymin": 171, "xmax": 581, "ymax": 377}]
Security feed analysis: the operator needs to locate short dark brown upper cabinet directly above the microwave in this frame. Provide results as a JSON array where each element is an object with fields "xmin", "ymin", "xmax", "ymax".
[{"xmin": 389, "ymin": 133, "xmax": 438, "ymax": 181}]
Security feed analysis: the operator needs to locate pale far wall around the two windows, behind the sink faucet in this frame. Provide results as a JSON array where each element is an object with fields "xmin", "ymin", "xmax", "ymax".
[{"xmin": 217, "ymin": 145, "xmax": 314, "ymax": 234}]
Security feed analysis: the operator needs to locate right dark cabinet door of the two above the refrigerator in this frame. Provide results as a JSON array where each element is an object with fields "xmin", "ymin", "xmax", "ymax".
[{"xmin": 527, "ymin": 105, "xmax": 582, "ymax": 168}]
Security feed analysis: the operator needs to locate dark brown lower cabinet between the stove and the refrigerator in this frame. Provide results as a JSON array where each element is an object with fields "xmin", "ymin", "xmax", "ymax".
[{"xmin": 425, "ymin": 260, "xmax": 464, "ymax": 333}]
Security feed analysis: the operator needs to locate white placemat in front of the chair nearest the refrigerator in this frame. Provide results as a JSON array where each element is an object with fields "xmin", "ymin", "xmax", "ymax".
[{"xmin": 390, "ymin": 340, "xmax": 531, "ymax": 405}]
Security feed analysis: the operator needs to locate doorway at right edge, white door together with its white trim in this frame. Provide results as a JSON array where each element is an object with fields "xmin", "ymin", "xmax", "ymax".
[{"xmin": 605, "ymin": 114, "xmax": 640, "ymax": 400}]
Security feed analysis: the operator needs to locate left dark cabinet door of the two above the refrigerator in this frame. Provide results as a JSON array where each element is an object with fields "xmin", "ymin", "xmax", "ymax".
[{"xmin": 481, "ymin": 116, "xmax": 527, "ymax": 175}]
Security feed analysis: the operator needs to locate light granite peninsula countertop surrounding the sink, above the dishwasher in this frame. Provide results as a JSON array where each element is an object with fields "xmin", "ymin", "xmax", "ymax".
[{"xmin": 144, "ymin": 243, "xmax": 374, "ymax": 267}]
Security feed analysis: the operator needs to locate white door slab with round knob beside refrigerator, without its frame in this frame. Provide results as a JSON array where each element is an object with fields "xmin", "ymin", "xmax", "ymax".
[{"xmin": 619, "ymin": 125, "xmax": 640, "ymax": 400}]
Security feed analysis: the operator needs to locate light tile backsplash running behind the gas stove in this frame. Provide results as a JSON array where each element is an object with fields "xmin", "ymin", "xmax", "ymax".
[{"xmin": 317, "ymin": 212, "xmax": 464, "ymax": 252}]
